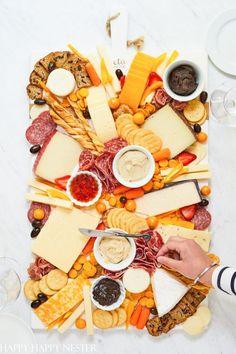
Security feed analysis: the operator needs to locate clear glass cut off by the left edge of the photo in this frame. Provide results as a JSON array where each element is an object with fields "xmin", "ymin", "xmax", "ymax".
[{"xmin": 0, "ymin": 257, "xmax": 21, "ymax": 311}]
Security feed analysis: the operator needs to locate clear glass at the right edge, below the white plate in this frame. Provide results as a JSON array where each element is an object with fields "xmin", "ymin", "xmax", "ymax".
[{"xmin": 210, "ymin": 83, "xmax": 236, "ymax": 127}]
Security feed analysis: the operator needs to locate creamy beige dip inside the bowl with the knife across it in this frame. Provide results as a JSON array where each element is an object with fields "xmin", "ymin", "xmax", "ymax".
[{"xmin": 99, "ymin": 237, "xmax": 131, "ymax": 264}]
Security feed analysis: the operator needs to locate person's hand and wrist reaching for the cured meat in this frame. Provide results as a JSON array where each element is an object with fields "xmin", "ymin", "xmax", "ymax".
[{"xmin": 157, "ymin": 237, "xmax": 214, "ymax": 285}]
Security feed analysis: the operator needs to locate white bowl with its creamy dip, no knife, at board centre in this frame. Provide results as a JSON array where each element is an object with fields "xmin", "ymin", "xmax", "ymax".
[{"xmin": 112, "ymin": 145, "xmax": 155, "ymax": 188}]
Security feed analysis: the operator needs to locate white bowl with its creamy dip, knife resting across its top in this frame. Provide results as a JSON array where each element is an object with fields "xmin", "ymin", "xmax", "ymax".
[{"xmin": 93, "ymin": 229, "xmax": 136, "ymax": 271}]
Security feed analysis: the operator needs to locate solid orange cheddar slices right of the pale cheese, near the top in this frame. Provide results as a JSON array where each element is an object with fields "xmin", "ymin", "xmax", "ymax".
[{"xmin": 119, "ymin": 52, "xmax": 155, "ymax": 110}]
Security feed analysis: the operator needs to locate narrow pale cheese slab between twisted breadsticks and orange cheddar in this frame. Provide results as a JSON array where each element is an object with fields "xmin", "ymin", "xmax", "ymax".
[{"xmin": 87, "ymin": 85, "xmax": 118, "ymax": 142}]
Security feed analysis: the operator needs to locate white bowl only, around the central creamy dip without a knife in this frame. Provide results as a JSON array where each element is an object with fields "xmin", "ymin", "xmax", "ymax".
[{"xmin": 112, "ymin": 145, "xmax": 155, "ymax": 188}]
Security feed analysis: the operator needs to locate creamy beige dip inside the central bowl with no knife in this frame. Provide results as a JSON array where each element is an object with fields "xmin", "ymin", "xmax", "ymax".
[{"xmin": 118, "ymin": 150, "xmax": 150, "ymax": 182}]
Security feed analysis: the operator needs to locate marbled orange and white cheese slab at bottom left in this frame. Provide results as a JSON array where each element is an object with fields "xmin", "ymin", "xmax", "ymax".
[{"xmin": 34, "ymin": 276, "xmax": 87, "ymax": 327}]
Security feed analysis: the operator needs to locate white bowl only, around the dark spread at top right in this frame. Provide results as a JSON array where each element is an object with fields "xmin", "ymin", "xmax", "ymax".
[{"xmin": 163, "ymin": 60, "xmax": 205, "ymax": 102}]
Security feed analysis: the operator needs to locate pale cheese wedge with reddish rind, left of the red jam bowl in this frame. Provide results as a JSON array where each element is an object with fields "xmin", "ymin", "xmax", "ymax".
[{"xmin": 35, "ymin": 132, "xmax": 82, "ymax": 182}]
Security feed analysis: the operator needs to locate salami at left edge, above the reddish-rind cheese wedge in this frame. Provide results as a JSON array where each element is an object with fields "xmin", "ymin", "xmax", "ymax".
[{"xmin": 25, "ymin": 111, "xmax": 56, "ymax": 145}]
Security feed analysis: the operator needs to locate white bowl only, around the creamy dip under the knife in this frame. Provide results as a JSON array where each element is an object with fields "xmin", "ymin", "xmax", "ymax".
[{"xmin": 93, "ymin": 229, "xmax": 136, "ymax": 272}]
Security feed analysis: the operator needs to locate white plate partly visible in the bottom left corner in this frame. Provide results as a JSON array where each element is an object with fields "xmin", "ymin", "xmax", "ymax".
[{"xmin": 0, "ymin": 313, "xmax": 35, "ymax": 344}]
